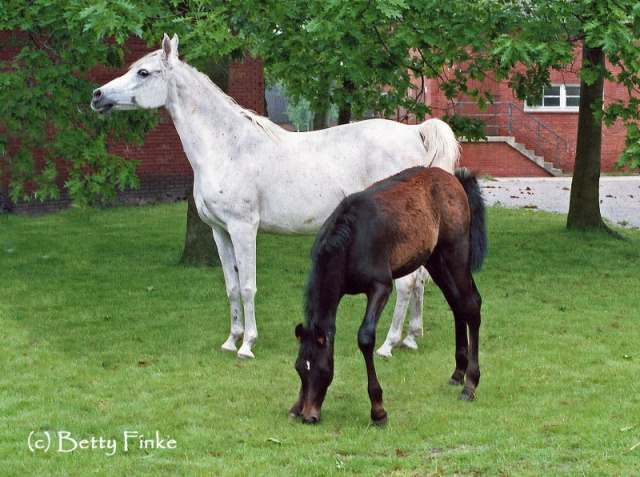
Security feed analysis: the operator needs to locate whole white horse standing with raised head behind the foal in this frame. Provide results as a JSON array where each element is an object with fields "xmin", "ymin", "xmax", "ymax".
[{"xmin": 91, "ymin": 34, "xmax": 459, "ymax": 358}]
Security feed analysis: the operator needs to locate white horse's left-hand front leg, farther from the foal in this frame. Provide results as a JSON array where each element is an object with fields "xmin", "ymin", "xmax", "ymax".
[{"xmin": 213, "ymin": 228, "xmax": 244, "ymax": 353}]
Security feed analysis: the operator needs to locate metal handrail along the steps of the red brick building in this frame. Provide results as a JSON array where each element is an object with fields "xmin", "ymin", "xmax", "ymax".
[{"xmin": 453, "ymin": 101, "xmax": 568, "ymax": 169}]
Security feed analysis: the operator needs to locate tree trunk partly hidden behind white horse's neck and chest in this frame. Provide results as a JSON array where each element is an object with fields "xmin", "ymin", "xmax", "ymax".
[{"xmin": 180, "ymin": 60, "xmax": 229, "ymax": 267}]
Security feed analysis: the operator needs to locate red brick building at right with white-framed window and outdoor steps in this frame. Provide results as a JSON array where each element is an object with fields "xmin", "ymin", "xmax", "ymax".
[{"xmin": 425, "ymin": 50, "xmax": 629, "ymax": 177}]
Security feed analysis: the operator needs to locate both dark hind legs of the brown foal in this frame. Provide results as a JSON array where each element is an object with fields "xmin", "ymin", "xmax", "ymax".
[{"xmin": 427, "ymin": 249, "xmax": 482, "ymax": 401}]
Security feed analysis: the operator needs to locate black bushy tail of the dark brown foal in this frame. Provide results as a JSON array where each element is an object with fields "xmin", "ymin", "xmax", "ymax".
[{"xmin": 455, "ymin": 167, "xmax": 488, "ymax": 270}]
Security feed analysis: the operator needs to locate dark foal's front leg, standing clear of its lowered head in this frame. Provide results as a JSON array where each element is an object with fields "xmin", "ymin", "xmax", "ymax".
[{"xmin": 358, "ymin": 282, "xmax": 391, "ymax": 426}]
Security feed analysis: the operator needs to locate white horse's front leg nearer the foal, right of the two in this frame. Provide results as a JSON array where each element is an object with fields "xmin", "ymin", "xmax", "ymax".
[{"xmin": 227, "ymin": 222, "xmax": 258, "ymax": 358}]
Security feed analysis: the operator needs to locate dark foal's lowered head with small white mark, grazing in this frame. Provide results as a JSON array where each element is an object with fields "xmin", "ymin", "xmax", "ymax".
[{"xmin": 291, "ymin": 325, "xmax": 333, "ymax": 424}]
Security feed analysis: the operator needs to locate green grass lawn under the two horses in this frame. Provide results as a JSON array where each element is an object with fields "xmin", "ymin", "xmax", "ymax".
[{"xmin": 0, "ymin": 204, "xmax": 640, "ymax": 476}]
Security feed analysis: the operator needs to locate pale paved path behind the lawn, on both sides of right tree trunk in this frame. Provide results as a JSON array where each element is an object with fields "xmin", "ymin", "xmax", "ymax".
[{"xmin": 479, "ymin": 175, "xmax": 640, "ymax": 228}]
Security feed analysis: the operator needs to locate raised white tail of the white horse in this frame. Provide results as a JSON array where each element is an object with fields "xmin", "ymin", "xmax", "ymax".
[{"xmin": 418, "ymin": 118, "xmax": 460, "ymax": 174}]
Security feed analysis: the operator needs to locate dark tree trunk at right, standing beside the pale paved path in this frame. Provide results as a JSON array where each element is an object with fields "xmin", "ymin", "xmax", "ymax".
[{"xmin": 567, "ymin": 45, "xmax": 610, "ymax": 231}]
